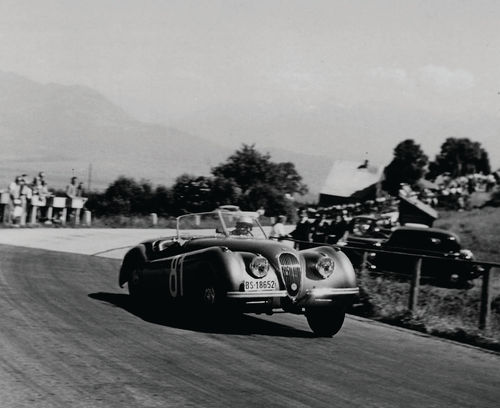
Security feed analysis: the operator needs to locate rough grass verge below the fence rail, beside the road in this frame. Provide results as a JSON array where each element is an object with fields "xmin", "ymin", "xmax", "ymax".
[{"xmin": 351, "ymin": 271, "xmax": 500, "ymax": 352}]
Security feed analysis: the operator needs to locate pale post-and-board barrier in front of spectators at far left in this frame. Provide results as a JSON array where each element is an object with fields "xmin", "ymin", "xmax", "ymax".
[{"xmin": 0, "ymin": 192, "xmax": 92, "ymax": 226}]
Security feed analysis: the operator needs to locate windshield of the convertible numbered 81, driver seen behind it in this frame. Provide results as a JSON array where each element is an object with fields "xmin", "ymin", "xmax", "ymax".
[{"xmin": 177, "ymin": 211, "xmax": 267, "ymax": 239}]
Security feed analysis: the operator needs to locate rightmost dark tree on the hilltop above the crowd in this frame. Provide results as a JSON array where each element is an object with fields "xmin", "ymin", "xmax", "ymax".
[{"xmin": 430, "ymin": 137, "xmax": 491, "ymax": 177}]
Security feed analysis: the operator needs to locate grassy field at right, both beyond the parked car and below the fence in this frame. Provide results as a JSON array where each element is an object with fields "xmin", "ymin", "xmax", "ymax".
[{"xmin": 354, "ymin": 208, "xmax": 500, "ymax": 350}]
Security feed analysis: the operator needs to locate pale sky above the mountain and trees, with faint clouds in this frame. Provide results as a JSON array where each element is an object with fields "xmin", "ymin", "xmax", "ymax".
[{"xmin": 0, "ymin": 0, "xmax": 500, "ymax": 167}]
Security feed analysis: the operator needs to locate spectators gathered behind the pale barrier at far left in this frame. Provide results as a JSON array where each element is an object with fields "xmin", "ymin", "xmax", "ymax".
[{"xmin": 2, "ymin": 171, "xmax": 84, "ymax": 225}]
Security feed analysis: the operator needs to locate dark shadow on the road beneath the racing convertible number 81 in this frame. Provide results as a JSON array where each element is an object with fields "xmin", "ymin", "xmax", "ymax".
[{"xmin": 88, "ymin": 292, "xmax": 315, "ymax": 338}]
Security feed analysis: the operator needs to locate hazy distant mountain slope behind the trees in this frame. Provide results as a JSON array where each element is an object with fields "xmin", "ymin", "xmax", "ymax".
[{"xmin": 0, "ymin": 71, "xmax": 331, "ymax": 198}]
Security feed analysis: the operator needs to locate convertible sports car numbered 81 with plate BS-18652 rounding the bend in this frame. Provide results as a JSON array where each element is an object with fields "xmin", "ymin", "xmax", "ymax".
[{"xmin": 119, "ymin": 210, "xmax": 358, "ymax": 337}]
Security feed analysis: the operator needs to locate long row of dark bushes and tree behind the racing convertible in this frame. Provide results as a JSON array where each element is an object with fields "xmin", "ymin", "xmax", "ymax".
[{"xmin": 87, "ymin": 144, "xmax": 307, "ymax": 216}]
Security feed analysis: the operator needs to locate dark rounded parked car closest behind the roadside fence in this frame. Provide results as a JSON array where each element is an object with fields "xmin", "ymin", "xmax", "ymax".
[{"xmin": 369, "ymin": 227, "xmax": 482, "ymax": 286}]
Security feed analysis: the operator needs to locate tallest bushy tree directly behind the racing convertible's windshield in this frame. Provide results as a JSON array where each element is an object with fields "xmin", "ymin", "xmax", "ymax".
[{"xmin": 212, "ymin": 144, "xmax": 307, "ymax": 215}]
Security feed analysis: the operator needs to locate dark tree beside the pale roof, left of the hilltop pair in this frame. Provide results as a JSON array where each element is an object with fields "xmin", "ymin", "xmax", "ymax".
[{"xmin": 382, "ymin": 139, "xmax": 429, "ymax": 195}]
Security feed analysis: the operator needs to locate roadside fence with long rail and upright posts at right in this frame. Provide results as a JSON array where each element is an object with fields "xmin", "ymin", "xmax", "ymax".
[{"xmin": 274, "ymin": 238, "xmax": 500, "ymax": 332}]
